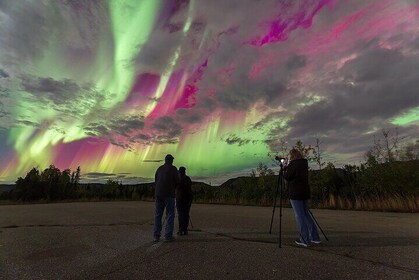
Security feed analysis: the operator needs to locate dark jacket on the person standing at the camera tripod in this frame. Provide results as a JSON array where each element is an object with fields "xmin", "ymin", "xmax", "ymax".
[{"xmin": 284, "ymin": 159, "xmax": 310, "ymax": 200}]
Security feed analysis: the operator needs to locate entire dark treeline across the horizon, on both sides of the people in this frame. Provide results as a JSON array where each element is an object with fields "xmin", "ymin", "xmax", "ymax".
[{"xmin": 0, "ymin": 131, "xmax": 419, "ymax": 212}]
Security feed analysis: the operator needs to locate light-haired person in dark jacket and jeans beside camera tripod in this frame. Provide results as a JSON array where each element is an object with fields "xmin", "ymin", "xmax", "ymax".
[{"xmin": 284, "ymin": 149, "xmax": 321, "ymax": 247}]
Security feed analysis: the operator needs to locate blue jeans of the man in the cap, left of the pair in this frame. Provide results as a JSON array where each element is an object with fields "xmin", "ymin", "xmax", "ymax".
[{"xmin": 153, "ymin": 197, "xmax": 175, "ymax": 238}]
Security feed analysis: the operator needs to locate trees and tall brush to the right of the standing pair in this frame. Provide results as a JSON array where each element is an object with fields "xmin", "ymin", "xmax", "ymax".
[{"xmin": 195, "ymin": 130, "xmax": 419, "ymax": 212}]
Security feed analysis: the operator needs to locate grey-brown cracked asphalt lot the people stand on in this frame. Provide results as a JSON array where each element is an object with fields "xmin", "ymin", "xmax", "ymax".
[{"xmin": 0, "ymin": 202, "xmax": 419, "ymax": 279}]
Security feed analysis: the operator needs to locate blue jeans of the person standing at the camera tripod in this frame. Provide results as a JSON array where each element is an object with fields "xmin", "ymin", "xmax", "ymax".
[{"xmin": 290, "ymin": 199, "xmax": 320, "ymax": 244}]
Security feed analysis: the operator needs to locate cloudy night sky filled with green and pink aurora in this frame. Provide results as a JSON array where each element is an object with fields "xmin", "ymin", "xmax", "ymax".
[{"xmin": 0, "ymin": 0, "xmax": 419, "ymax": 183}]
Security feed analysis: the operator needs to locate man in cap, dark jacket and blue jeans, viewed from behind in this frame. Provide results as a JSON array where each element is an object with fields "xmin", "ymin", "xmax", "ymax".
[{"xmin": 153, "ymin": 154, "xmax": 179, "ymax": 242}]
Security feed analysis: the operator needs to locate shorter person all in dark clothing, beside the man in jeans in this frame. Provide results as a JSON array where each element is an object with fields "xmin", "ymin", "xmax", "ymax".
[{"xmin": 176, "ymin": 166, "xmax": 192, "ymax": 235}]
